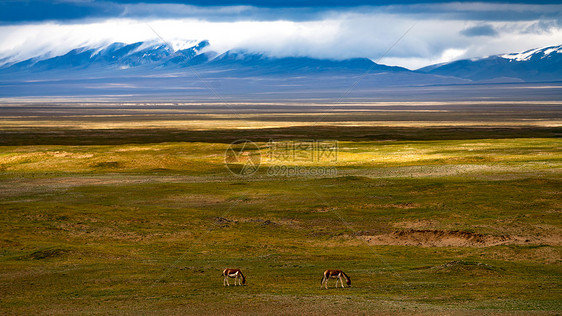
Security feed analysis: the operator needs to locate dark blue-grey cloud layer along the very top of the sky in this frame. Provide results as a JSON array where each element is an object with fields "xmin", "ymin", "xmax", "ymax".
[{"xmin": 0, "ymin": 0, "xmax": 562, "ymax": 25}]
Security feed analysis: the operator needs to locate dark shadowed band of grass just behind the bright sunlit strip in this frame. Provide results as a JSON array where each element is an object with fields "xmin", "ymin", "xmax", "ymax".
[{"xmin": 0, "ymin": 123, "xmax": 562, "ymax": 146}]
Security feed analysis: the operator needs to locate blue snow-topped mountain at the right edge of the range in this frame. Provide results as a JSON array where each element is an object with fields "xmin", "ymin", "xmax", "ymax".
[{"xmin": 417, "ymin": 45, "xmax": 562, "ymax": 82}]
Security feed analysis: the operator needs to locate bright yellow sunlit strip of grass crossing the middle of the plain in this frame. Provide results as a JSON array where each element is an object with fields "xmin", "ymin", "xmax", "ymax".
[{"xmin": 0, "ymin": 139, "xmax": 562, "ymax": 175}]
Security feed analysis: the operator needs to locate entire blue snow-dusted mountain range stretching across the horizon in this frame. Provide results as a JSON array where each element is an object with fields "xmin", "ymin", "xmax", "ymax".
[{"xmin": 0, "ymin": 41, "xmax": 562, "ymax": 97}]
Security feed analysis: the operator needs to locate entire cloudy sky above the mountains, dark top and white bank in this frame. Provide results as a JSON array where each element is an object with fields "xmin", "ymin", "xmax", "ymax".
[{"xmin": 0, "ymin": 0, "xmax": 562, "ymax": 69}]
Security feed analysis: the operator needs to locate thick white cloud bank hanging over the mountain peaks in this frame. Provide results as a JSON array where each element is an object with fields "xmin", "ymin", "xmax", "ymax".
[{"xmin": 0, "ymin": 11, "xmax": 562, "ymax": 69}]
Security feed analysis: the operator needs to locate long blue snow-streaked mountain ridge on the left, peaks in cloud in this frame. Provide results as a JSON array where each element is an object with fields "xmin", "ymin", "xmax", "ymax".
[{"xmin": 0, "ymin": 41, "xmax": 408, "ymax": 75}]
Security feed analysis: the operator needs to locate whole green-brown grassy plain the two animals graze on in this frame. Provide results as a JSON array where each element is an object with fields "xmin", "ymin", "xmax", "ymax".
[{"xmin": 0, "ymin": 102, "xmax": 562, "ymax": 314}]
